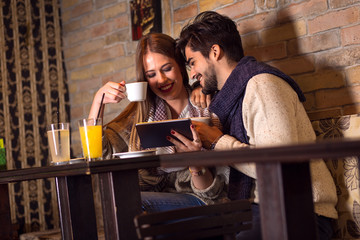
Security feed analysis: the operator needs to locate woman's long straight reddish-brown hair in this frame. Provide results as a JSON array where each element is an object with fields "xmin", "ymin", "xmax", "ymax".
[{"xmin": 109, "ymin": 33, "xmax": 189, "ymax": 151}]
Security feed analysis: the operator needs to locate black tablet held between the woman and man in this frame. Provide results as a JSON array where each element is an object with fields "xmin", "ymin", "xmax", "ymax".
[{"xmin": 136, "ymin": 118, "xmax": 193, "ymax": 148}]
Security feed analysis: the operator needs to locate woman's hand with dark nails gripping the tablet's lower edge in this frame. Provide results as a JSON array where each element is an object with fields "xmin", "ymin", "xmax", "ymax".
[{"xmin": 167, "ymin": 125, "xmax": 202, "ymax": 152}]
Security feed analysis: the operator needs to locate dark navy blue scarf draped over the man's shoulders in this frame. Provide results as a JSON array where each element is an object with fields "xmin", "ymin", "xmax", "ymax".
[{"xmin": 209, "ymin": 56, "xmax": 306, "ymax": 200}]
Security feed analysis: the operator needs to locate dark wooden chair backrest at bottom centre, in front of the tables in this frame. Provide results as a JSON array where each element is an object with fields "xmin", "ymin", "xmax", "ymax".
[{"xmin": 134, "ymin": 200, "xmax": 252, "ymax": 240}]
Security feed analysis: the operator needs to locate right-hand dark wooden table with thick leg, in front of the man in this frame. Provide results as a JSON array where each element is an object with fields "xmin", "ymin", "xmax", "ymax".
[{"xmin": 160, "ymin": 140, "xmax": 360, "ymax": 240}]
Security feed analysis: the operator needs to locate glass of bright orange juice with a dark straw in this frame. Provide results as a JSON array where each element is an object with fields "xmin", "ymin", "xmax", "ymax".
[{"xmin": 79, "ymin": 118, "xmax": 102, "ymax": 161}]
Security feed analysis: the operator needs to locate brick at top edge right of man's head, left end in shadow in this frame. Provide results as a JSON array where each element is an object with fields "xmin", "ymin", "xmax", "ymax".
[{"xmin": 278, "ymin": 0, "xmax": 328, "ymax": 22}]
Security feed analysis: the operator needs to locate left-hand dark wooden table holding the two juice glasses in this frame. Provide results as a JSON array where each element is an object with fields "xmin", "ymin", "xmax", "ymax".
[{"xmin": 0, "ymin": 156, "xmax": 159, "ymax": 240}]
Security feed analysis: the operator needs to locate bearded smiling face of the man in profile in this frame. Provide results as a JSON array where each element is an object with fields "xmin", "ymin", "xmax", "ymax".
[{"xmin": 185, "ymin": 46, "xmax": 218, "ymax": 94}]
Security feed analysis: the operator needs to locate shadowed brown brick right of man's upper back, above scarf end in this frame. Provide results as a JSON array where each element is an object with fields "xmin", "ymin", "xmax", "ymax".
[{"xmin": 294, "ymin": 70, "xmax": 345, "ymax": 92}]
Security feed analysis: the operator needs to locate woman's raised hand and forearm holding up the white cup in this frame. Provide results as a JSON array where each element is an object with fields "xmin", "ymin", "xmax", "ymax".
[{"xmin": 89, "ymin": 81, "xmax": 126, "ymax": 118}]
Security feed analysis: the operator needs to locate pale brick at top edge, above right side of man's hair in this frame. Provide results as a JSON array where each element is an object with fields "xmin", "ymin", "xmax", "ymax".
[{"xmin": 217, "ymin": 0, "xmax": 255, "ymax": 20}]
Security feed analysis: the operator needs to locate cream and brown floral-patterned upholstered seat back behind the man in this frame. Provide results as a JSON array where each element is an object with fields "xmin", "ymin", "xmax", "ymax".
[{"xmin": 312, "ymin": 114, "xmax": 360, "ymax": 240}]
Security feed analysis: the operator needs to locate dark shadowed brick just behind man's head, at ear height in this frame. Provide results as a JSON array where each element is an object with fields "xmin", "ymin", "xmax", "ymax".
[{"xmin": 245, "ymin": 42, "xmax": 286, "ymax": 61}]
